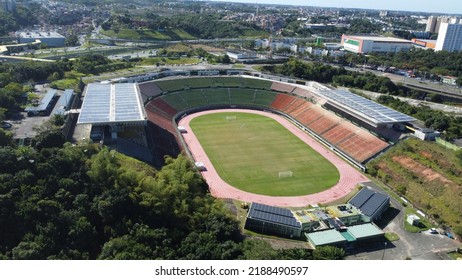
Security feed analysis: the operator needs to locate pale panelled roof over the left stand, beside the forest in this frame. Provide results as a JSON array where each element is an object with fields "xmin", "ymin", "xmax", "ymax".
[{"xmin": 77, "ymin": 83, "xmax": 145, "ymax": 124}]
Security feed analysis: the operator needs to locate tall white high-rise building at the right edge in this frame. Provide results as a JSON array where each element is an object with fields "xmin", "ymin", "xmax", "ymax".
[{"xmin": 435, "ymin": 23, "xmax": 462, "ymax": 52}]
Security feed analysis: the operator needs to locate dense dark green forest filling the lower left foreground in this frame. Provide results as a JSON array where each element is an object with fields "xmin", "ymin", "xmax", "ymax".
[{"xmin": 0, "ymin": 117, "xmax": 344, "ymax": 260}]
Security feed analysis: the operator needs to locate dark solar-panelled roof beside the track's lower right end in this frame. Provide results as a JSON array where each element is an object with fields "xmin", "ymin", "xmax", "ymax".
[{"xmin": 349, "ymin": 188, "xmax": 390, "ymax": 217}]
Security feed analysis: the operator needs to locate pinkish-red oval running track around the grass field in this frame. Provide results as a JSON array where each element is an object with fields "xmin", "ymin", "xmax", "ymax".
[{"xmin": 179, "ymin": 109, "xmax": 369, "ymax": 207}]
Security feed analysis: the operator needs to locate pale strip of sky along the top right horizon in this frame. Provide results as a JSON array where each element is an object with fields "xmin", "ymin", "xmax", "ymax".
[{"xmin": 214, "ymin": 0, "xmax": 462, "ymax": 14}]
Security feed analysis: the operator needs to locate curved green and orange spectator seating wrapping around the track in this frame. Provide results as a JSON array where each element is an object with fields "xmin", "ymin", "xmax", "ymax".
[{"xmin": 146, "ymin": 80, "xmax": 389, "ymax": 164}]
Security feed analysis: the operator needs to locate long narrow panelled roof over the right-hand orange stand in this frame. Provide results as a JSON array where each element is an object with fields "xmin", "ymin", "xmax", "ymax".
[{"xmin": 318, "ymin": 90, "xmax": 416, "ymax": 125}]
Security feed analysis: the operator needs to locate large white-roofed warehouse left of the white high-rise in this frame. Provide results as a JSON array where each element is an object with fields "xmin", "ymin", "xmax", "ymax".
[{"xmin": 341, "ymin": 34, "xmax": 412, "ymax": 54}]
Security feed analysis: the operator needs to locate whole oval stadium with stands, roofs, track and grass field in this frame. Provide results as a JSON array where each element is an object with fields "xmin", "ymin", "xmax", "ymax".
[{"xmin": 78, "ymin": 72, "xmax": 415, "ymax": 207}]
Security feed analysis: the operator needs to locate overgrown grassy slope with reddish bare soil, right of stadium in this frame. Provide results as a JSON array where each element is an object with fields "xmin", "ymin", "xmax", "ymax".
[{"xmin": 367, "ymin": 138, "xmax": 462, "ymax": 235}]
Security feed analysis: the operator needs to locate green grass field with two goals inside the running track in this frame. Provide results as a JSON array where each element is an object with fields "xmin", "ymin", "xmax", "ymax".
[{"xmin": 191, "ymin": 113, "xmax": 340, "ymax": 196}]
